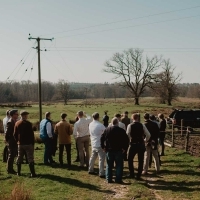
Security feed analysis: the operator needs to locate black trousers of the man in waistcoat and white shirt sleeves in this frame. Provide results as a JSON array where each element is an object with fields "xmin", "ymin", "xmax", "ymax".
[{"xmin": 128, "ymin": 144, "xmax": 145, "ymax": 177}]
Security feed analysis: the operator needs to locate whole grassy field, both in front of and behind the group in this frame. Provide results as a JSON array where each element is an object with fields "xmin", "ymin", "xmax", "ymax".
[{"xmin": 0, "ymin": 98, "xmax": 200, "ymax": 200}]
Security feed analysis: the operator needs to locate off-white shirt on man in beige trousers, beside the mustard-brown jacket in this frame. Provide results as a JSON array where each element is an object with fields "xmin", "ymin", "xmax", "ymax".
[{"xmin": 73, "ymin": 117, "xmax": 92, "ymax": 139}]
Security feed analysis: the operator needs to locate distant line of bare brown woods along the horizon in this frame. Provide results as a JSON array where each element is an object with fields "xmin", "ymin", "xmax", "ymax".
[{"xmin": 0, "ymin": 80, "xmax": 200, "ymax": 104}]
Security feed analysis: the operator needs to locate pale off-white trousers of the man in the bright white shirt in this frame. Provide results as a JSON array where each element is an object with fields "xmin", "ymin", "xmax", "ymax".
[{"xmin": 88, "ymin": 147, "xmax": 106, "ymax": 176}]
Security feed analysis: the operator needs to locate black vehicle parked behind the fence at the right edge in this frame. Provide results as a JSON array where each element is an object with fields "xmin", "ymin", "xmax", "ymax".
[{"xmin": 167, "ymin": 109, "xmax": 200, "ymax": 129}]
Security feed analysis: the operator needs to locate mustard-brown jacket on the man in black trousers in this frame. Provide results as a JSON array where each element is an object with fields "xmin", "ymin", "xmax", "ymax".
[{"xmin": 54, "ymin": 120, "xmax": 73, "ymax": 144}]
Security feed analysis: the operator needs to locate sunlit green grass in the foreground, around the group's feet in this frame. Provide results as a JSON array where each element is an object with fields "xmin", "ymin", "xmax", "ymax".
[{"xmin": 0, "ymin": 136, "xmax": 200, "ymax": 200}]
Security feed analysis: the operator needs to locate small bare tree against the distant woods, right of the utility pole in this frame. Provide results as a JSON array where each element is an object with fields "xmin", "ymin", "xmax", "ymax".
[{"xmin": 57, "ymin": 80, "xmax": 70, "ymax": 105}]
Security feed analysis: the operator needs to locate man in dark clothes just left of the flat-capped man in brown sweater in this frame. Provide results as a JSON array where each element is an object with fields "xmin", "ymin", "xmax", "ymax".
[{"xmin": 5, "ymin": 110, "xmax": 19, "ymax": 174}]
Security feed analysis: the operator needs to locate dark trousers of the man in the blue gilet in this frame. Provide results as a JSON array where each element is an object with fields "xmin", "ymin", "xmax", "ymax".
[{"xmin": 44, "ymin": 138, "xmax": 53, "ymax": 164}]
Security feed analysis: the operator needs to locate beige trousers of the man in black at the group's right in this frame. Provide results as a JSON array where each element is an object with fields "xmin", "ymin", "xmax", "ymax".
[{"xmin": 144, "ymin": 146, "xmax": 160, "ymax": 172}]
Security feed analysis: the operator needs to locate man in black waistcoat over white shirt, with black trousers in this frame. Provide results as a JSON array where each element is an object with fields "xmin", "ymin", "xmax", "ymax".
[{"xmin": 127, "ymin": 113, "xmax": 150, "ymax": 179}]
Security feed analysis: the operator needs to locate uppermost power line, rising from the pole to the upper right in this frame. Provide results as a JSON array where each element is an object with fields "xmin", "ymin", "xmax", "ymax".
[{"xmin": 40, "ymin": 6, "xmax": 200, "ymax": 36}]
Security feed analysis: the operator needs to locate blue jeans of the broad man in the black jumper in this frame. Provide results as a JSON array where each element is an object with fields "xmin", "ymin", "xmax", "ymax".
[{"xmin": 106, "ymin": 151, "xmax": 124, "ymax": 182}]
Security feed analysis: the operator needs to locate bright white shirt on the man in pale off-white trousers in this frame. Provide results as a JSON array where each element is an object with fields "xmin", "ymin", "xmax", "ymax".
[{"xmin": 89, "ymin": 120, "xmax": 106, "ymax": 148}]
